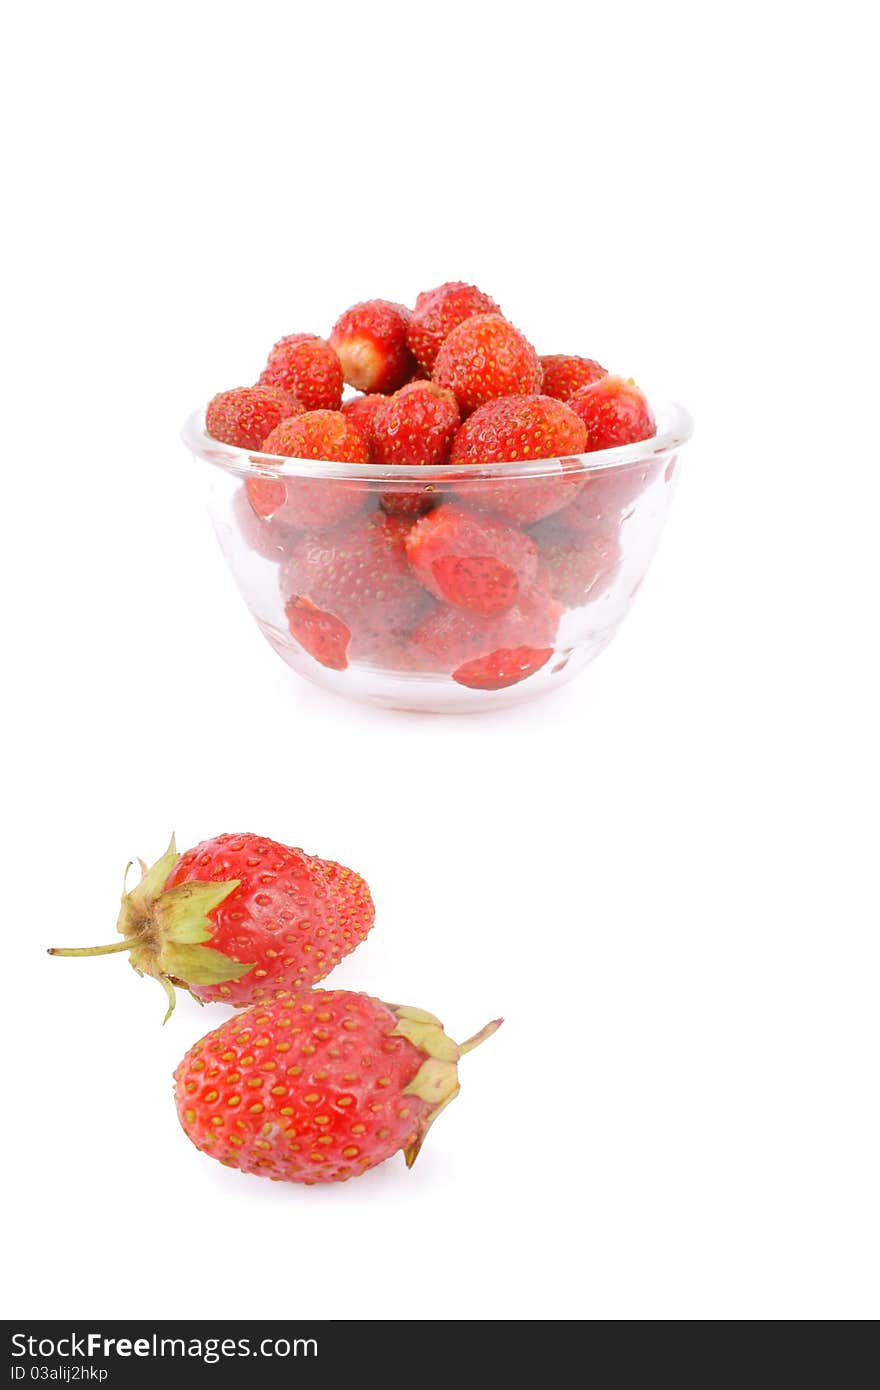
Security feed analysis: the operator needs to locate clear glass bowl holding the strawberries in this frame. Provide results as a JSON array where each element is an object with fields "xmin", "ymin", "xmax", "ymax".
[{"xmin": 184, "ymin": 404, "xmax": 691, "ymax": 712}]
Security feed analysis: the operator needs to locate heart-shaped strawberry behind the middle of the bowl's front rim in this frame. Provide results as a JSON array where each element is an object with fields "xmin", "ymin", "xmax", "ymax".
[{"xmin": 371, "ymin": 381, "xmax": 460, "ymax": 516}]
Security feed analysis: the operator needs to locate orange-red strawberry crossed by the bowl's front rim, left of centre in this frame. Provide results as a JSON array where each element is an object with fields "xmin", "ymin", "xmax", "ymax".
[{"xmin": 247, "ymin": 410, "xmax": 370, "ymax": 531}]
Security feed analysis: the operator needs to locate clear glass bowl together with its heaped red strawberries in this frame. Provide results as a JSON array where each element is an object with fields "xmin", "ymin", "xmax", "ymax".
[{"xmin": 184, "ymin": 281, "xmax": 691, "ymax": 713}]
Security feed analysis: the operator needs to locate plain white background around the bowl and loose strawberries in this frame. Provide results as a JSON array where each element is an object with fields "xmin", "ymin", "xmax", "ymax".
[{"xmin": 0, "ymin": 0, "xmax": 880, "ymax": 1319}]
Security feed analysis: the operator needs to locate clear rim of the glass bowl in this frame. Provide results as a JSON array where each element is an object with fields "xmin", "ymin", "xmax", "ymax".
[{"xmin": 182, "ymin": 400, "xmax": 694, "ymax": 485}]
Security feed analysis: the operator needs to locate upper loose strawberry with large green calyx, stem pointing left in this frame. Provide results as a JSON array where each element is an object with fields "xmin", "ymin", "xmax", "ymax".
[{"xmin": 49, "ymin": 834, "xmax": 374, "ymax": 1017}]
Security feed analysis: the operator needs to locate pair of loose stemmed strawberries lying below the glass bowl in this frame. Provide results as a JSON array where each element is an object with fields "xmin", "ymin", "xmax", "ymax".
[{"xmin": 50, "ymin": 834, "xmax": 500, "ymax": 1184}]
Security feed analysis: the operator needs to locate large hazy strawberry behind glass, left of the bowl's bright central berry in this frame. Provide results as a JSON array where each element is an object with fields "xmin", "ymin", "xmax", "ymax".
[{"xmin": 281, "ymin": 512, "xmax": 427, "ymax": 657}]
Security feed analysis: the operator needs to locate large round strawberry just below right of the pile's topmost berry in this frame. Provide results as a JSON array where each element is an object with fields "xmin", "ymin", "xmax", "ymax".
[{"xmin": 434, "ymin": 314, "xmax": 541, "ymax": 416}]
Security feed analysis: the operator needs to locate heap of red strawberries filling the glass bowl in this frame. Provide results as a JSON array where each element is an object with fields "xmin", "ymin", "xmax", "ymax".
[{"xmin": 206, "ymin": 282, "xmax": 656, "ymax": 689}]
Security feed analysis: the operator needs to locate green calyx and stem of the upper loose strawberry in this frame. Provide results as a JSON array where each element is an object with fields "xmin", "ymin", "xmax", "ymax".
[{"xmin": 49, "ymin": 835, "xmax": 253, "ymax": 1022}]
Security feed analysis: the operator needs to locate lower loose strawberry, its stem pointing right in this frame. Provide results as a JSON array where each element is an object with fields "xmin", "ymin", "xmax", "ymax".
[{"xmin": 174, "ymin": 990, "xmax": 502, "ymax": 1183}]
